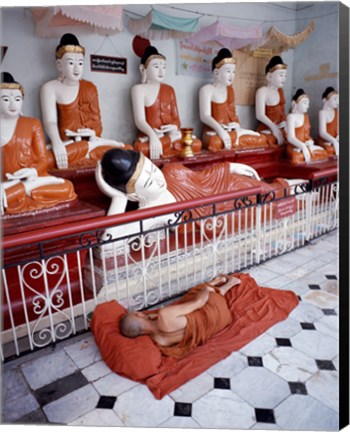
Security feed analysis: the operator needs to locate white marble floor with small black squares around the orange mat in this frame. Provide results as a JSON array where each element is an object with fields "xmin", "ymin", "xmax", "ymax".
[{"xmin": 2, "ymin": 231, "xmax": 339, "ymax": 430}]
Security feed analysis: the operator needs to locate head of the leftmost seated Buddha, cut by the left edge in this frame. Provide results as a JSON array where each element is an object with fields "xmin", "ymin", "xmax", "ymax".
[{"xmin": 0, "ymin": 72, "xmax": 24, "ymax": 119}]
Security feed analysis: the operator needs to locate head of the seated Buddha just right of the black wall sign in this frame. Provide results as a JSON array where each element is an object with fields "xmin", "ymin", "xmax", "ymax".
[{"xmin": 140, "ymin": 45, "xmax": 166, "ymax": 84}]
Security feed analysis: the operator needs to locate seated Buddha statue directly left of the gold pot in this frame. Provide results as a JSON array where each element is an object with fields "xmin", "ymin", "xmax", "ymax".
[{"xmin": 131, "ymin": 46, "xmax": 202, "ymax": 159}]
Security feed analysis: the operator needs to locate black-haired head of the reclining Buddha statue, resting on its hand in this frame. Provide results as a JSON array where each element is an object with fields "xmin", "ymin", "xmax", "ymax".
[{"xmin": 101, "ymin": 149, "xmax": 167, "ymax": 205}]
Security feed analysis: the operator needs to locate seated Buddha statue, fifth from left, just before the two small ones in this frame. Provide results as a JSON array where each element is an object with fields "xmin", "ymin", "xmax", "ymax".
[{"xmin": 255, "ymin": 56, "xmax": 287, "ymax": 145}]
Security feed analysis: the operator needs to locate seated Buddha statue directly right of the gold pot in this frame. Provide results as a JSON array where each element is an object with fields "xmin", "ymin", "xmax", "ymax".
[{"xmin": 199, "ymin": 48, "xmax": 269, "ymax": 152}]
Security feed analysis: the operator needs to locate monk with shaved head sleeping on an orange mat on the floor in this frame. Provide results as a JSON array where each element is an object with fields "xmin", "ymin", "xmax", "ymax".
[{"xmin": 120, "ymin": 275, "xmax": 241, "ymax": 359}]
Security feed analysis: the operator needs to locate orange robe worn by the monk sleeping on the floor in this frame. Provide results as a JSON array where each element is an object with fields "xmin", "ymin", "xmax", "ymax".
[{"xmin": 157, "ymin": 284, "xmax": 232, "ymax": 359}]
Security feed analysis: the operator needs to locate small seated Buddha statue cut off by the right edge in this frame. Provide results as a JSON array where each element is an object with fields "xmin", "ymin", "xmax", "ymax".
[{"xmin": 318, "ymin": 87, "xmax": 339, "ymax": 156}]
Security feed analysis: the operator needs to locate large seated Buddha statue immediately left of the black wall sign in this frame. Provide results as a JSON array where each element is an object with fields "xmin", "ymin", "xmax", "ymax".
[{"xmin": 40, "ymin": 33, "xmax": 131, "ymax": 168}]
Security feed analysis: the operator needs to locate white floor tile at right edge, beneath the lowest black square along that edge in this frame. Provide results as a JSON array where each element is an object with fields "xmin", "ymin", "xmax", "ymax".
[{"xmin": 306, "ymin": 370, "xmax": 339, "ymax": 412}]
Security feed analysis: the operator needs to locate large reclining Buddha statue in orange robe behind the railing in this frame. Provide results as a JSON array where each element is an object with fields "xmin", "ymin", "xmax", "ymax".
[{"xmin": 96, "ymin": 149, "xmax": 289, "ymax": 247}]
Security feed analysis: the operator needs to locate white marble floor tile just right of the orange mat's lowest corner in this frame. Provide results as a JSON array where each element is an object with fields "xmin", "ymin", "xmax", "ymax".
[{"xmin": 169, "ymin": 372, "xmax": 214, "ymax": 403}]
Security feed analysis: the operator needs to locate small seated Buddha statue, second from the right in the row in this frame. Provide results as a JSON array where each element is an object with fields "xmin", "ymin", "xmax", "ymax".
[{"xmin": 287, "ymin": 89, "xmax": 328, "ymax": 163}]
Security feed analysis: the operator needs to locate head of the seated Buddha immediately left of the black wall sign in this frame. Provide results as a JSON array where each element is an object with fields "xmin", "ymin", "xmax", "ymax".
[{"xmin": 56, "ymin": 33, "xmax": 85, "ymax": 86}]
